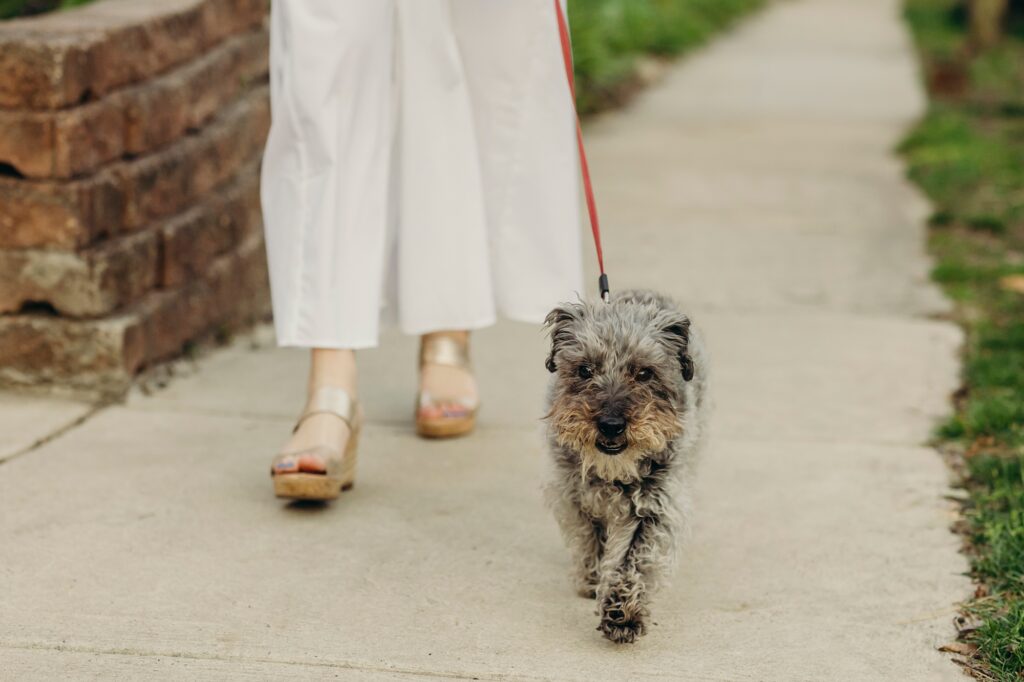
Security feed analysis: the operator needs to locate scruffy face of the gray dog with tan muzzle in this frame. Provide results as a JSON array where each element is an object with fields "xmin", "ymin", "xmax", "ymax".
[{"xmin": 546, "ymin": 296, "xmax": 693, "ymax": 480}]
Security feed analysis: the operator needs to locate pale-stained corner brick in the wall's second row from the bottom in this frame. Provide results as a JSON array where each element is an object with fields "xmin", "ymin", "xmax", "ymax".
[{"xmin": 0, "ymin": 229, "xmax": 160, "ymax": 317}]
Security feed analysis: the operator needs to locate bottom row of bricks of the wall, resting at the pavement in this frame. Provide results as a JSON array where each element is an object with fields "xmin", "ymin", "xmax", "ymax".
[{"xmin": 0, "ymin": 233, "xmax": 270, "ymax": 398}]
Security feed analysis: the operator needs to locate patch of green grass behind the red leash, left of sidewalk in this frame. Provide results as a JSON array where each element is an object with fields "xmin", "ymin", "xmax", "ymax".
[{"xmin": 569, "ymin": 0, "xmax": 763, "ymax": 114}]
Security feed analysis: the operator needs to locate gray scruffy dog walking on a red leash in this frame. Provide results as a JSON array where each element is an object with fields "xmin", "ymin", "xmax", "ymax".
[{"xmin": 546, "ymin": 291, "xmax": 709, "ymax": 642}]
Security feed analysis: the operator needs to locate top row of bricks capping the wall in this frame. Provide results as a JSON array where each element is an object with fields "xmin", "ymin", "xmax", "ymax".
[{"xmin": 0, "ymin": 0, "xmax": 267, "ymax": 110}]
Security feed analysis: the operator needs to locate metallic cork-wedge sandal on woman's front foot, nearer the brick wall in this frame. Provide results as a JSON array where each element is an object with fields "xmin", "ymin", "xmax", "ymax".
[{"xmin": 270, "ymin": 386, "xmax": 362, "ymax": 501}]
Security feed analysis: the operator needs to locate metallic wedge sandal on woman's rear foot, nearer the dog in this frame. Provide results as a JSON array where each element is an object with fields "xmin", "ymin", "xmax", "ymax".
[{"xmin": 416, "ymin": 335, "xmax": 480, "ymax": 438}]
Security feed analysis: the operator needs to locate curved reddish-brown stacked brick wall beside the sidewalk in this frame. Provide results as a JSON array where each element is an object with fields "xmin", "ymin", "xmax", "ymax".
[{"xmin": 0, "ymin": 0, "xmax": 269, "ymax": 397}]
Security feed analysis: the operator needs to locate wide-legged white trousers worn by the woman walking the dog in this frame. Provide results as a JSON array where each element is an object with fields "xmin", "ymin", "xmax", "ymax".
[{"xmin": 261, "ymin": 0, "xmax": 582, "ymax": 348}]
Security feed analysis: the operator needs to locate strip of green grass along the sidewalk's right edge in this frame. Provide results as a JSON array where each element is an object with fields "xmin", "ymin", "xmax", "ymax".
[{"xmin": 901, "ymin": 0, "xmax": 1024, "ymax": 680}]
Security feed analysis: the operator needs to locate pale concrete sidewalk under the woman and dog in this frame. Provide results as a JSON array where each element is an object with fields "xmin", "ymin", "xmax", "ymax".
[{"xmin": 0, "ymin": 0, "xmax": 969, "ymax": 681}]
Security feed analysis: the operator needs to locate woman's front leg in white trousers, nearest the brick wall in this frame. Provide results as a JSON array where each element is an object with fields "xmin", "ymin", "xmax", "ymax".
[{"xmin": 261, "ymin": 0, "xmax": 394, "ymax": 473}]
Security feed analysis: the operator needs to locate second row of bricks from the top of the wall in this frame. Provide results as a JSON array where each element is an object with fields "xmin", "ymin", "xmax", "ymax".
[{"xmin": 0, "ymin": 29, "xmax": 267, "ymax": 179}]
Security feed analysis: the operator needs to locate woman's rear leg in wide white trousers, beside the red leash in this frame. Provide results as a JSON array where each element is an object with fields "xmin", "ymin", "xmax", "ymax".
[{"xmin": 398, "ymin": 0, "xmax": 583, "ymax": 428}]
